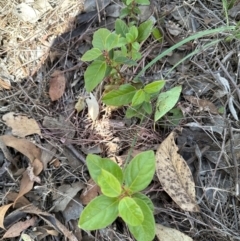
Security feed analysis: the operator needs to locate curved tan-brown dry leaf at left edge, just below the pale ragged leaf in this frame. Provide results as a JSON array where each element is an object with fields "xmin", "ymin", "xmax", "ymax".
[{"xmin": 0, "ymin": 135, "xmax": 41, "ymax": 163}]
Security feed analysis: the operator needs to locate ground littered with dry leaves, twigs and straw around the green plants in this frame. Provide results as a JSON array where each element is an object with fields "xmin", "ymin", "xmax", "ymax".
[{"xmin": 0, "ymin": 0, "xmax": 240, "ymax": 241}]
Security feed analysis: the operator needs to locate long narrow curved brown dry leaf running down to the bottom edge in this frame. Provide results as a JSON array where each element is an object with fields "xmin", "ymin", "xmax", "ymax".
[{"xmin": 19, "ymin": 205, "xmax": 78, "ymax": 241}]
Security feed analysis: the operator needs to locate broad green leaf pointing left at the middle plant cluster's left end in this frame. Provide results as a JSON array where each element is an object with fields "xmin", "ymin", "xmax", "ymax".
[{"xmin": 102, "ymin": 84, "xmax": 136, "ymax": 106}]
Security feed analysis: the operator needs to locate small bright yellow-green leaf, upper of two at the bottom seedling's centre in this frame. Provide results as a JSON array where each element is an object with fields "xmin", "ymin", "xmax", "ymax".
[{"xmin": 98, "ymin": 169, "xmax": 122, "ymax": 197}]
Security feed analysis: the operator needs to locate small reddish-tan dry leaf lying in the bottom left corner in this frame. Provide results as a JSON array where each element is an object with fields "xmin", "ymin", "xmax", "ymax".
[{"xmin": 3, "ymin": 217, "xmax": 36, "ymax": 238}]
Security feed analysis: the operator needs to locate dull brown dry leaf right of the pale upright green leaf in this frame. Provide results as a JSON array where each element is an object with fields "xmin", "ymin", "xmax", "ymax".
[{"xmin": 184, "ymin": 95, "xmax": 218, "ymax": 115}]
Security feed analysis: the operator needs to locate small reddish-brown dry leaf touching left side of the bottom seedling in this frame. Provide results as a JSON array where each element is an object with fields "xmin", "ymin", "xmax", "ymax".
[{"xmin": 80, "ymin": 179, "xmax": 101, "ymax": 205}]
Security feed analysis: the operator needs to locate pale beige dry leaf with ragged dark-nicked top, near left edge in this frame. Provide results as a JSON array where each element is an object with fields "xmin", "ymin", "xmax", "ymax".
[{"xmin": 2, "ymin": 112, "xmax": 41, "ymax": 137}]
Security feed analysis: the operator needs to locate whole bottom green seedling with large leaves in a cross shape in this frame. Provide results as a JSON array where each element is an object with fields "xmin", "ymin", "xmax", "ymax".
[{"xmin": 78, "ymin": 151, "xmax": 155, "ymax": 241}]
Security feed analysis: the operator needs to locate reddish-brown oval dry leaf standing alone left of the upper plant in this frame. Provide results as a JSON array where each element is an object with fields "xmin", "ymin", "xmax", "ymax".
[{"xmin": 49, "ymin": 70, "xmax": 66, "ymax": 101}]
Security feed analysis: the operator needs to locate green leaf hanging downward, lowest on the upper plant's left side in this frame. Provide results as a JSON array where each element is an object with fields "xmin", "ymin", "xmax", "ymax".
[{"xmin": 84, "ymin": 60, "xmax": 107, "ymax": 92}]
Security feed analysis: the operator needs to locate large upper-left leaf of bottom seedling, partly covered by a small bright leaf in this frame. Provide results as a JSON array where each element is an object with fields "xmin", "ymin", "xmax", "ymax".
[{"xmin": 86, "ymin": 154, "xmax": 123, "ymax": 184}]
